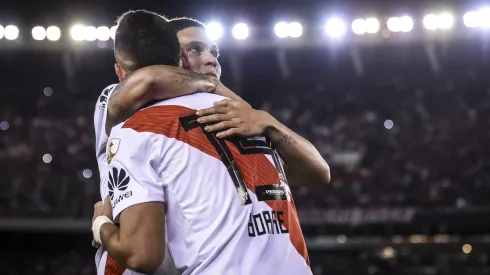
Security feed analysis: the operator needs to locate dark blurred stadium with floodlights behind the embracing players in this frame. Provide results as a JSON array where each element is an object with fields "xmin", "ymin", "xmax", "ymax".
[{"xmin": 0, "ymin": 0, "xmax": 490, "ymax": 275}]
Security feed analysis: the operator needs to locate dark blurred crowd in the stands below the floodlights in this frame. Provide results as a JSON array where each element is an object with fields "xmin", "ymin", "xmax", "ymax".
[{"xmin": 0, "ymin": 47, "xmax": 490, "ymax": 220}]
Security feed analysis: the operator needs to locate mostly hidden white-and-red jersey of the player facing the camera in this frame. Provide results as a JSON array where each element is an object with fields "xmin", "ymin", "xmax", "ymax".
[{"xmin": 94, "ymin": 84, "xmax": 177, "ymax": 275}]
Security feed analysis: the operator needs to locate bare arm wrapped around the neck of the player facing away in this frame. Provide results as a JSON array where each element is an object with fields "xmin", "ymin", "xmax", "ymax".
[{"xmin": 106, "ymin": 65, "xmax": 242, "ymax": 133}]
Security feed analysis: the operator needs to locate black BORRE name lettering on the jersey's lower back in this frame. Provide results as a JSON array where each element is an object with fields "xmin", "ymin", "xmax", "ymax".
[{"xmin": 248, "ymin": 211, "xmax": 289, "ymax": 237}]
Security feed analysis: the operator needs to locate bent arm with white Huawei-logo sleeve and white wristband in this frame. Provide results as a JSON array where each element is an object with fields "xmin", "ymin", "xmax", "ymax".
[{"xmin": 92, "ymin": 129, "xmax": 165, "ymax": 274}]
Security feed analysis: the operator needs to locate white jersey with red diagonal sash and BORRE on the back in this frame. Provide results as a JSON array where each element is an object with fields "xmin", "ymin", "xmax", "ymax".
[{"xmin": 107, "ymin": 93, "xmax": 312, "ymax": 275}]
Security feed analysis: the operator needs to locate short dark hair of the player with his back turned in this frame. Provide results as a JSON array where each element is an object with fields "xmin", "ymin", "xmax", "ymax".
[{"xmin": 114, "ymin": 10, "xmax": 181, "ymax": 72}]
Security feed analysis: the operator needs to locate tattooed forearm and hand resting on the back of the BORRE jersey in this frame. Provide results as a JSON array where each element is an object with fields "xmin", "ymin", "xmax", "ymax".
[{"xmin": 197, "ymin": 100, "xmax": 330, "ymax": 187}]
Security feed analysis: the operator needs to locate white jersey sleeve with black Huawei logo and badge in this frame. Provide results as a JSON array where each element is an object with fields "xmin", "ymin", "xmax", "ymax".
[{"xmin": 106, "ymin": 127, "xmax": 165, "ymax": 221}]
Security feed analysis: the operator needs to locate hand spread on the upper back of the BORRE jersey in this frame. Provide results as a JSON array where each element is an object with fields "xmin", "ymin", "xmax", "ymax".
[{"xmin": 197, "ymin": 99, "xmax": 273, "ymax": 138}]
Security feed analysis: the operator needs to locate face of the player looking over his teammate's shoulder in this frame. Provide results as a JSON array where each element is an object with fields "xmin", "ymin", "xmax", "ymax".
[{"xmin": 177, "ymin": 27, "xmax": 221, "ymax": 79}]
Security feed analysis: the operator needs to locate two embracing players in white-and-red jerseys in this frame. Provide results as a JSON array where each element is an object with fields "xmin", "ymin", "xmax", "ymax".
[{"xmin": 92, "ymin": 10, "xmax": 330, "ymax": 275}]
